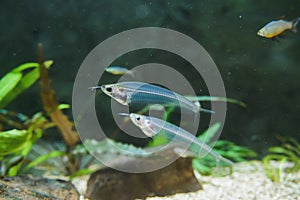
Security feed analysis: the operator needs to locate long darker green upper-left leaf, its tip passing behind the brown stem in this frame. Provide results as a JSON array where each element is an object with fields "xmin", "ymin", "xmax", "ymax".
[{"xmin": 0, "ymin": 60, "xmax": 53, "ymax": 108}]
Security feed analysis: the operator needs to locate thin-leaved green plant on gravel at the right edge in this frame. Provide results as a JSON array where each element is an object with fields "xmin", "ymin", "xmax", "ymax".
[{"xmin": 262, "ymin": 136, "xmax": 300, "ymax": 182}]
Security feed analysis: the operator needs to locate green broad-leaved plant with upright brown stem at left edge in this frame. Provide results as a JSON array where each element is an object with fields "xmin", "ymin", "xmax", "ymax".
[{"xmin": 0, "ymin": 45, "xmax": 80, "ymax": 176}]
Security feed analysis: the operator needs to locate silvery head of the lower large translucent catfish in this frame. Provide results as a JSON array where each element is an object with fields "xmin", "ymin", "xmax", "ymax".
[{"xmin": 129, "ymin": 113, "xmax": 157, "ymax": 137}]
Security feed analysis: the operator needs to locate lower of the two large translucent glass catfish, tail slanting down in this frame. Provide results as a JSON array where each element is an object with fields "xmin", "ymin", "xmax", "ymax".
[{"xmin": 125, "ymin": 113, "xmax": 233, "ymax": 165}]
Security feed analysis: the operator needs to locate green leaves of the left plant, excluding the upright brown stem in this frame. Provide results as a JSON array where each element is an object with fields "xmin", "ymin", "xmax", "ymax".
[{"xmin": 0, "ymin": 60, "xmax": 53, "ymax": 176}]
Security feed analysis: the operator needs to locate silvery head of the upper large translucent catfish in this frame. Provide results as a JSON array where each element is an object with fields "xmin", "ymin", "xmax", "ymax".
[{"xmin": 101, "ymin": 84, "xmax": 128, "ymax": 105}]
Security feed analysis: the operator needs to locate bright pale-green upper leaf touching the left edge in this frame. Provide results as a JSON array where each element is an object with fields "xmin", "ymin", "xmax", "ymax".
[{"xmin": 0, "ymin": 72, "xmax": 22, "ymax": 103}]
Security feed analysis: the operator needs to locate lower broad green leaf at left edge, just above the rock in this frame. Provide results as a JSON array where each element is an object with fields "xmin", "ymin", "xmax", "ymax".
[{"xmin": 0, "ymin": 129, "xmax": 31, "ymax": 156}]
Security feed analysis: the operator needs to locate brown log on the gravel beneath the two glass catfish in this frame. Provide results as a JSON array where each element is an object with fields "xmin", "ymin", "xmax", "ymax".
[{"xmin": 86, "ymin": 158, "xmax": 201, "ymax": 200}]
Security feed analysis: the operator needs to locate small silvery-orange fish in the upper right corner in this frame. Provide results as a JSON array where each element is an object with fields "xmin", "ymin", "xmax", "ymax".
[{"xmin": 257, "ymin": 18, "xmax": 300, "ymax": 38}]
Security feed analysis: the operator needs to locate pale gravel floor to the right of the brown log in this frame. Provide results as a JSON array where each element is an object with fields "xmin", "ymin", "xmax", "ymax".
[{"xmin": 147, "ymin": 161, "xmax": 300, "ymax": 200}]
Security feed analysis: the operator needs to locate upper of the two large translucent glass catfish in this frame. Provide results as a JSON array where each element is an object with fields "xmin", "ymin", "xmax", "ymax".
[{"xmin": 90, "ymin": 82, "xmax": 213, "ymax": 114}]
